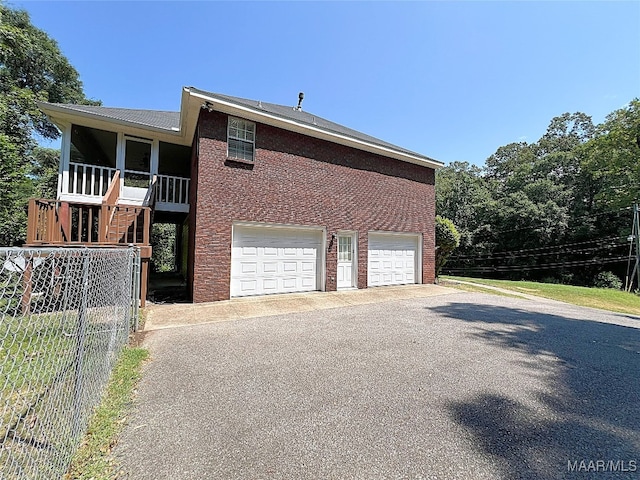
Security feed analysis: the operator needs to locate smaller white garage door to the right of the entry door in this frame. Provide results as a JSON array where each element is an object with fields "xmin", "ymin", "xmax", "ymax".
[{"xmin": 368, "ymin": 233, "xmax": 420, "ymax": 287}]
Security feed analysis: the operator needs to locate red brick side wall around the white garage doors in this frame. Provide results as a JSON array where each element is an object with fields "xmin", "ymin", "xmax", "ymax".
[{"xmin": 189, "ymin": 111, "xmax": 435, "ymax": 302}]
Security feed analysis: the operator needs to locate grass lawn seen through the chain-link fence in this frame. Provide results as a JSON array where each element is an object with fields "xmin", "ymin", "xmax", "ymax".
[{"xmin": 0, "ymin": 307, "xmax": 133, "ymax": 478}]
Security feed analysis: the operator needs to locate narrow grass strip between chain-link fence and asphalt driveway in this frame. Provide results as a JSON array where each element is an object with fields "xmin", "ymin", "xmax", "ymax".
[{"xmin": 63, "ymin": 347, "xmax": 149, "ymax": 480}]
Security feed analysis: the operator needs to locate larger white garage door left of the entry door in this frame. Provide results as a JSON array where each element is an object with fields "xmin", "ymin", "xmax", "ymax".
[{"xmin": 231, "ymin": 226, "xmax": 322, "ymax": 297}]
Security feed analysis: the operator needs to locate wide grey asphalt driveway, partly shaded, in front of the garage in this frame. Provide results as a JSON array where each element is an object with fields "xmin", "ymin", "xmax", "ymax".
[{"xmin": 116, "ymin": 292, "xmax": 640, "ymax": 479}]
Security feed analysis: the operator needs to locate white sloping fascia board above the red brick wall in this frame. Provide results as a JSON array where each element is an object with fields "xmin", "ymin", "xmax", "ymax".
[{"xmin": 185, "ymin": 88, "xmax": 444, "ymax": 169}]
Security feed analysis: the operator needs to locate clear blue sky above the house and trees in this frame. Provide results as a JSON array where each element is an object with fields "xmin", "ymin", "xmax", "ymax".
[{"xmin": 10, "ymin": 1, "xmax": 640, "ymax": 165}]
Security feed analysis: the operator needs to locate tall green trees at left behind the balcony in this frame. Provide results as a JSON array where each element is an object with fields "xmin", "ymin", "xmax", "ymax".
[{"xmin": 0, "ymin": 0, "xmax": 99, "ymax": 245}]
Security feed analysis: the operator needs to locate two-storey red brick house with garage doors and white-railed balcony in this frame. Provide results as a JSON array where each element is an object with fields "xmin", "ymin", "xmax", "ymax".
[{"xmin": 35, "ymin": 87, "xmax": 442, "ymax": 302}]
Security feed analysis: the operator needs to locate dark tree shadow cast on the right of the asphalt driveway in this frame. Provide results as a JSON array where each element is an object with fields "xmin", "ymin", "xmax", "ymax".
[{"xmin": 427, "ymin": 303, "xmax": 640, "ymax": 479}]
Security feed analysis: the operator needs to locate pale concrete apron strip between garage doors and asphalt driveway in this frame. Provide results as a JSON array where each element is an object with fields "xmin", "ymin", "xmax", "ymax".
[{"xmin": 144, "ymin": 285, "xmax": 459, "ymax": 331}]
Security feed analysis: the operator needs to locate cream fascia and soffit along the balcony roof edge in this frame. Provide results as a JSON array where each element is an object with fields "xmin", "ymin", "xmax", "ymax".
[{"xmin": 38, "ymin": 103, "xmax": 193, "ymax": 146}]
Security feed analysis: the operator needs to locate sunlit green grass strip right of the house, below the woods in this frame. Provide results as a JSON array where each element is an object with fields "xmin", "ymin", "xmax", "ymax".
[{"xmin": 442, "ymin": 276, "xmax": 640, "ymax": 315}]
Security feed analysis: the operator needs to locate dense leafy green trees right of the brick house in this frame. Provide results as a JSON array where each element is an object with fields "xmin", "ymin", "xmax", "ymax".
[{"xmin": 436, "ymin": 99, "xmax": 640, "ymax": 284}]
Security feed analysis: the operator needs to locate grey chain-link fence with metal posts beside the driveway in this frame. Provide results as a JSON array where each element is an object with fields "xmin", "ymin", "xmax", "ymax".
[{"xmin": 0, "ymin": 248, "xmax": 139, "ymax": 479}]
